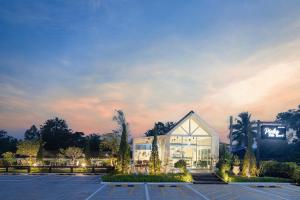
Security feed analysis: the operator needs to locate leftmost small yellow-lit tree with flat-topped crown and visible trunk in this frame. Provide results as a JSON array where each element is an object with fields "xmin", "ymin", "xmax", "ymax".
[{"xmin": 17, "ymin": 140, "xmax": 40, "ymax": 165}]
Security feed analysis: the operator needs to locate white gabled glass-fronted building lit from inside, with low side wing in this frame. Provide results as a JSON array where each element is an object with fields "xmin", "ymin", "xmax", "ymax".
[{"xmin": 132, "ymin": 111, "xmax": 219, "ymax": 171}]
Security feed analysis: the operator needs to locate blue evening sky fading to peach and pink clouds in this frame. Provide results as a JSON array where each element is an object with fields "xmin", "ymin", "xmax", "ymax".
[{"xmin": 0, "ymin": 0, "xmax": 300, "ymax": 141}]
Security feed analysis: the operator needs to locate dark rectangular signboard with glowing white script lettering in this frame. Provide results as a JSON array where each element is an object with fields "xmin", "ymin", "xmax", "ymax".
[{"xmin": 261, "ymin": 125, "xmax": 286, "ymax": 140}]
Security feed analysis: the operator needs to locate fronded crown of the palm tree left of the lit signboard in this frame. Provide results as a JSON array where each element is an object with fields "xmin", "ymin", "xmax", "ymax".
[{"xmin": 232, "ymin": 112, "xmax": 256, "ymax": 149}]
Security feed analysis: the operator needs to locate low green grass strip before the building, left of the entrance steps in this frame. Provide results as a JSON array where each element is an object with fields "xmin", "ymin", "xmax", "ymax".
[{"xmin": 102, "ymin": 174, "xmax": 193, "ymax": 182}]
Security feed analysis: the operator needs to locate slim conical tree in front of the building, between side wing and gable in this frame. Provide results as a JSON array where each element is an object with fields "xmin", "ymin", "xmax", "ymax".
[{"xmin": 149, "ymin": 124, "xmax": 161, "ymax": 174}]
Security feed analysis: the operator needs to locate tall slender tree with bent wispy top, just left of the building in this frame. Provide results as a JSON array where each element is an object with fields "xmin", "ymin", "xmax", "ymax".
[{"xmin": 113, "ymin": 110, "xmax": 130, "ymax": 174}]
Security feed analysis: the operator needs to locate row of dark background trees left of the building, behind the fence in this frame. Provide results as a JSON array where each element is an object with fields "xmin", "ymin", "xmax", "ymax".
[{"xmin": 0, "ymin": 117, "xmax": 113, "ymax": 157}]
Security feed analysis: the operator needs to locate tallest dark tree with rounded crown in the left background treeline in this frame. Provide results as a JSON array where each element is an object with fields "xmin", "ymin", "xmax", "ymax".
[{"xmin": 40, "ymin": 117, "xmax": 72, "ymax": 153}]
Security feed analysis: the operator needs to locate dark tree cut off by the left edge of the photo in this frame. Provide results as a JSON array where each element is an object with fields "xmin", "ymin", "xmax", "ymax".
[{"xmin": 0, "ymin": 130, "xmax": 18, "ymax": 155}]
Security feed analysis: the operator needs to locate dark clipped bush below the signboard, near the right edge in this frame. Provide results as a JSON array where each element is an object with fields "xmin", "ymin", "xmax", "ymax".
[{"xmin": 260, "ymin": 161, "xmax": 297, "ymax": 178}]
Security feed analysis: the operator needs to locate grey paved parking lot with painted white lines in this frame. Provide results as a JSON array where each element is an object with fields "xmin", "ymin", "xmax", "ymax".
[{"xmin": 0, "ymin": 175, "xmax": 300, "ymax": 200}]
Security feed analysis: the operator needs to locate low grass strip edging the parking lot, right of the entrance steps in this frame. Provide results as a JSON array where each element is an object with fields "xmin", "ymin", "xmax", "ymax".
[{"xmin": 228, "ymin": 176, "xmax": 293, "ymax": 183}]
